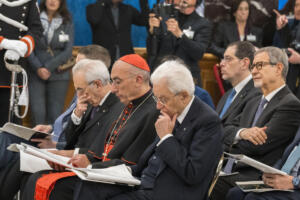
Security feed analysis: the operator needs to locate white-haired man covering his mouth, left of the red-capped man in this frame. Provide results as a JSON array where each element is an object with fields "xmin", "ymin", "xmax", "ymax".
[{"xmin": 0, "ymin": 59, "xmax": 123, "ymax": 200}]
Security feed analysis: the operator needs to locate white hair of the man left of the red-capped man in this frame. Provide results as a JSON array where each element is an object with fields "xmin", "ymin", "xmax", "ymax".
[{"xmin": 72, "ymin": 59, "xmax": 110, "ymax": 85}]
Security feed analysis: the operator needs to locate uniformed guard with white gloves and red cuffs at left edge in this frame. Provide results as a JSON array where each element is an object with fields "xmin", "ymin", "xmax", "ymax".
[{"xmin": 0, "ymin": 0, "xmax": 42, "ymax": 126}]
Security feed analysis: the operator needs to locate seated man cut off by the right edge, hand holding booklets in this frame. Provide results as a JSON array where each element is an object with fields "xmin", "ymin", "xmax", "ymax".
[{"xmin": 226, "ymin": 126, "xmax": 300, "ymax": 200}]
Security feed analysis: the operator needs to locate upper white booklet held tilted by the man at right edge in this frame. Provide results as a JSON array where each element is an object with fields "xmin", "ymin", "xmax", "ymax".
[{"xmin": 224, "ymin": 152, "xmax": 286, "ymax": 175}]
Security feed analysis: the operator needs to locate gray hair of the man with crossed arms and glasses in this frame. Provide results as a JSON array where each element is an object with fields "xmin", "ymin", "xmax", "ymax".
[{"xmin": 254, "ymin": 47, "xmax": 289, "ymax": 80}]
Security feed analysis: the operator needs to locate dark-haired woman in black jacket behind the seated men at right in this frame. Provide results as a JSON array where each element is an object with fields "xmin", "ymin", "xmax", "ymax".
[{"xmin": 209, "ymin": 0, "xmax": 262, "ymax": 58}]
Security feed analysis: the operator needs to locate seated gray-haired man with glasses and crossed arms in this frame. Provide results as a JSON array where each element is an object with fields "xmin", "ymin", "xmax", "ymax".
[{"xmin": 212, "ymin": 47, "xmax": 300, "ymax": 200}]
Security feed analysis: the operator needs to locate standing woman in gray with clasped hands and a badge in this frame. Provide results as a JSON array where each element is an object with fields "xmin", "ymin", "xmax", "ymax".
[{"xmin": 29, "ymin": 0, "xmax": 73, "ymax": 125}]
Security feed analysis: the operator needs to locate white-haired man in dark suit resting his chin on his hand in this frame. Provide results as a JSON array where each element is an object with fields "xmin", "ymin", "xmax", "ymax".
[{"xmin": 71, "ymin": 58, "xmax": 222, "ymax": 200}]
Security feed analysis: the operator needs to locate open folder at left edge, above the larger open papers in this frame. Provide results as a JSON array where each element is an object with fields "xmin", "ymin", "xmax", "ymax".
[{"xmin": 0, "ymin": 122, "xmax": 51, "ymax": 140}]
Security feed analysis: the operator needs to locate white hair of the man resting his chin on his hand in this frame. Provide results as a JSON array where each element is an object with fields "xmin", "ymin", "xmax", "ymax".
[{"xmin": 151, "ymin": 60, "xmax": 195, "ymax": 96}]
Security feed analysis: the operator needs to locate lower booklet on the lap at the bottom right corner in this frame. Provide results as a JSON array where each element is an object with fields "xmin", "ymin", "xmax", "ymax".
[{"xmin": 235, "ymin": 181, "xmax": 293, "ymax": 193}]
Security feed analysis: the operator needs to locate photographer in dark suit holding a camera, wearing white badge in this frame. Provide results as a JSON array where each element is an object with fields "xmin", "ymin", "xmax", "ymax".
[{"xmin": 147, "ymin": 0, "xmax": 212, "ymax": 85}]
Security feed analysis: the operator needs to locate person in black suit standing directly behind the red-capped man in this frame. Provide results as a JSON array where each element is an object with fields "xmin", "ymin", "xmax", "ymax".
[{"xmin": 86, "ymin": 0, "xmax": 149, "ymax": 63}]
